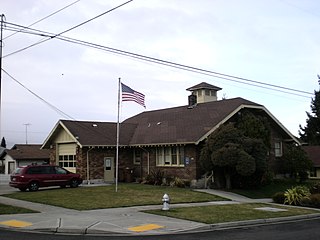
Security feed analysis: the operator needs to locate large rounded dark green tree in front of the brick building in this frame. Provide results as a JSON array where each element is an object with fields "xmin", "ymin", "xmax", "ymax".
[{"xmin": 200, "ymin": 123, "xmax": 267, "ymax": 189}]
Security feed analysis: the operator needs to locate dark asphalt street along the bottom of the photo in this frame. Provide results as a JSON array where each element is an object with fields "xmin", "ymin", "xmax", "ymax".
[{"xmin": 0, "ymin": 218, "xmax": 320, "ymax": 240}]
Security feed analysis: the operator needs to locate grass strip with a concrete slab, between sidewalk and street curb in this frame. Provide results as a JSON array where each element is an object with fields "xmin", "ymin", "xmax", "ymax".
[{"xmin": 144, "ymin": 203, "xmax": 319, "ymax": 224}]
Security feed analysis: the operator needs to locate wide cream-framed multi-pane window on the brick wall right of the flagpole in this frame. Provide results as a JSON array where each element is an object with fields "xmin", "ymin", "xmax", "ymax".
[{"xmin": 156, "ymin": 146, "xmax": 184, "ymax": 166}]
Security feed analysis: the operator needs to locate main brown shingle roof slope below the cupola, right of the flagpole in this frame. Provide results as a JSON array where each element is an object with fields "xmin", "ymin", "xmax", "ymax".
[{"xmin": 123, "ymin": 98, "xmax": 261, "ymax": 145}]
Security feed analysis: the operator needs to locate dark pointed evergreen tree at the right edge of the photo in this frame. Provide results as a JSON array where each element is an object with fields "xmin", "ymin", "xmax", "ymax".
[{"xmin": 299, "ymin": 75, "xmax": 320, "ymax": 145}]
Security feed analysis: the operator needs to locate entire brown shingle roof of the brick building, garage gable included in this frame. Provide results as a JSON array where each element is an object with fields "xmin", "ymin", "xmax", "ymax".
[{"xmin": 42, "ymin": 98, "xmax": 299, "ymax": 148}]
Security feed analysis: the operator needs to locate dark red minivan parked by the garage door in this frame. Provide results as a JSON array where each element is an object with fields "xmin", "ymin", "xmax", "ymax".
[{"xmin": 9, "ymin": 165, "xmax": 82, "ymax": 191}]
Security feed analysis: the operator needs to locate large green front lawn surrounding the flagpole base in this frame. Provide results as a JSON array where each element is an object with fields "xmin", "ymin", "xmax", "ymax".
[{"xmin": 4, "ymin": 184, "xmax": 225, "ymax": 210}]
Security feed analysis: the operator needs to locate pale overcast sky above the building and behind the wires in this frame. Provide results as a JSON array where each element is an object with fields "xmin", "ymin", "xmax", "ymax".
[{"xmin": 0, "ymin": 0, "xmax": 320, "ymax": 146}]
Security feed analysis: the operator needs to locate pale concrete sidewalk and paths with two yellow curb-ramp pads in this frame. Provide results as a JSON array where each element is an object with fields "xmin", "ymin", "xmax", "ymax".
[{"xmin": 0, "ymin": 185, "xmax": 320, "ymax": 235}]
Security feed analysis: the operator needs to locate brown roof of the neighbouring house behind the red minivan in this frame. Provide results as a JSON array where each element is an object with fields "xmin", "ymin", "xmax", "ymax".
[{"xmin": 6, "ymin": 144, "xmax": 50, "ymax": 160}]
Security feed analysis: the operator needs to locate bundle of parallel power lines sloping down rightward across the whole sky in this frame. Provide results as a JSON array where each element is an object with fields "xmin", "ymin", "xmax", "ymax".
[{"xmin": 4, "ymin": 20, "xmax": 313, "ymax": 98}]
